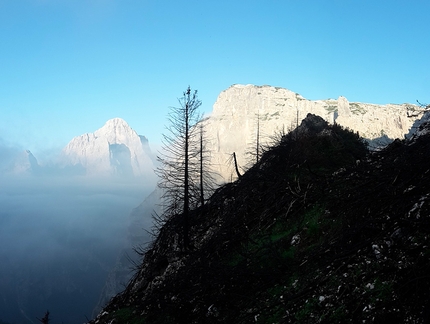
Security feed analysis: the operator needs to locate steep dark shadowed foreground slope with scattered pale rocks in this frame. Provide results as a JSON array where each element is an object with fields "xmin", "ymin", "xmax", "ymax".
[{"xmin": 92, "ymin": 115, "xmax": 430, "ymax": 324}]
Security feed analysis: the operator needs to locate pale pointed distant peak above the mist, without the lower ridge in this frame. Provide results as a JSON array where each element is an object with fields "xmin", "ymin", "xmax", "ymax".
[{"xmin": 62, "ymin": 118, "xmax": 154, "ymax": 177}]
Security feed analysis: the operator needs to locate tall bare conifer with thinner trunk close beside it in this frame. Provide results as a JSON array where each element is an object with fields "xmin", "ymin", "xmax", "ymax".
[{"xmin": 156, "ymin": 87, "xmax": 210, "ymax": 250}]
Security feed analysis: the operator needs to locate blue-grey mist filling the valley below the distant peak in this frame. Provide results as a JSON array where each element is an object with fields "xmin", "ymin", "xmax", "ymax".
[{"xmin": 0, "ymin": 147, "xmax": 155, "ymax": 324}]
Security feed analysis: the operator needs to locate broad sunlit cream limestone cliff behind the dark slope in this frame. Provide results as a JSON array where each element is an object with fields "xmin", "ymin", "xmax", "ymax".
[{"xmin": 207, "ymin": 85, "xmax": 414, "ymax": 181}]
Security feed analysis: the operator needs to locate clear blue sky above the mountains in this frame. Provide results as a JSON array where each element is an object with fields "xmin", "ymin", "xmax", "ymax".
[{"xmin": 0, "ymin": 0, "xmax": 430, "ymax": 157}]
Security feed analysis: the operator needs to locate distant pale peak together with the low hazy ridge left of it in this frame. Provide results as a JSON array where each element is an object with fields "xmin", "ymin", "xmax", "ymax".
[{"xmin": 0, "ymin": 118, "xmax": 156, "ymax": 182}]
